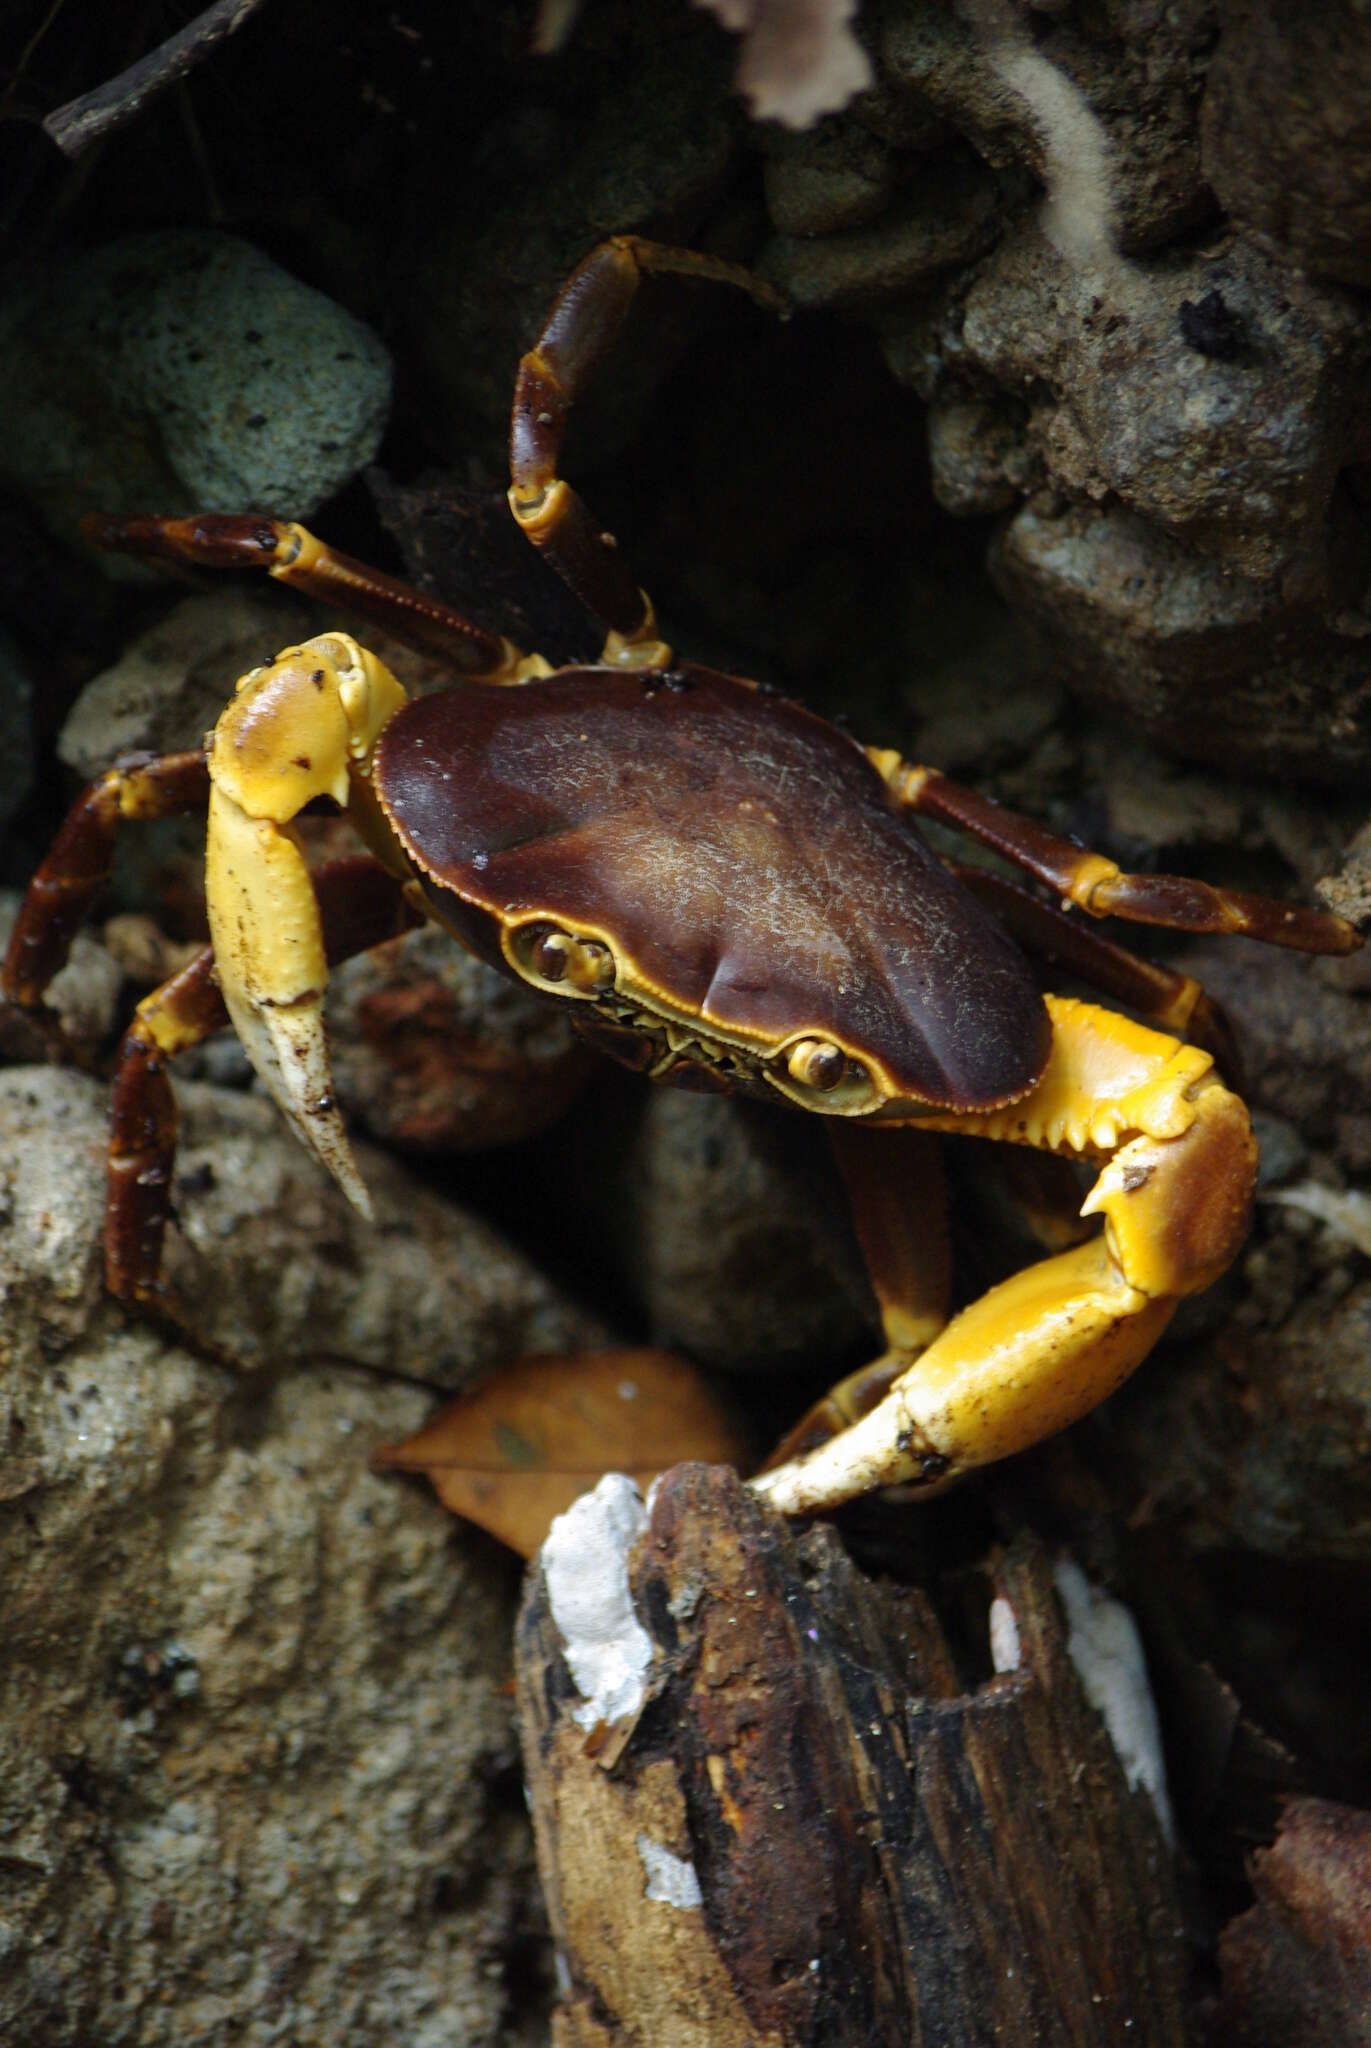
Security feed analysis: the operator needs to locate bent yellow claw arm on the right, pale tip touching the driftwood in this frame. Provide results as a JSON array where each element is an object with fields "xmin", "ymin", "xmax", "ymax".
[{"xmin": 754, "ymin": 995, "xmax": 1256, "ymax": 1513}]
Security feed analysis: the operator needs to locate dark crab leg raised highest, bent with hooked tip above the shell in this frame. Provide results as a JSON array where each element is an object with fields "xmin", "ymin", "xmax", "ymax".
[{"xmin": 510, "ymin": 236, "xmax": 785, "ymax": 639}]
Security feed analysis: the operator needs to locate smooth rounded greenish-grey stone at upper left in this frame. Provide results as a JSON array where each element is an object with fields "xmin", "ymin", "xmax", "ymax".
[{"xmin": 0, "ymin": 227, "xmax": 391, "ymax": 557}]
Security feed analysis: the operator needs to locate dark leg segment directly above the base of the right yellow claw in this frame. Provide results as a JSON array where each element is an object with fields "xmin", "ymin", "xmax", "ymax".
[{"xmin": 955, "ymin": 864, "xmax": 1242, "ymax": 1087}]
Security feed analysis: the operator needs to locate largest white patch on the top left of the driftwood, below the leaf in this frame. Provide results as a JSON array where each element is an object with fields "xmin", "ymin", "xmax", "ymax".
[{"xmin": 543, "ymin": 1473, "xmax": 652, "ymax": 1729}]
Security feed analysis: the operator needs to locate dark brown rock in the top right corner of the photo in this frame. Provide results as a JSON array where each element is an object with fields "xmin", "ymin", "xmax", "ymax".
[{"xmin": 1201, "ymin": 0, "xmax": 1371, "ymax": 287}]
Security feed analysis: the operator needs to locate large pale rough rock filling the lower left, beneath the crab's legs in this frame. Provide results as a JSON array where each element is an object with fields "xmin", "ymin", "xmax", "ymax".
[{"xmin": 0, "ymin": 1069, "xmax": 588, "ymax": 2048}]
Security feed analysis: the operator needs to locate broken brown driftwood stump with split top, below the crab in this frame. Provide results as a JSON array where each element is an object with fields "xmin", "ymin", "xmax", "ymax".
[{"xmin": 516, "ymin": 1464, "xmax": 1187, "ymax": 2048}]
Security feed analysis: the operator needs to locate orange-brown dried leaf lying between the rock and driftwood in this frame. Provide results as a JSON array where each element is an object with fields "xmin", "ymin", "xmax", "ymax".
[{"xmin": 371, "ymin": 1350, "xmax": 746, "ymax": 1556}]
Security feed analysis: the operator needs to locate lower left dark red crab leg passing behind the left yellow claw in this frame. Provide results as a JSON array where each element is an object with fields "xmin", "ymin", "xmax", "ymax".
[{"xmin": 105, "ymin": 856, "xmax": 424, "ymax": 1302}]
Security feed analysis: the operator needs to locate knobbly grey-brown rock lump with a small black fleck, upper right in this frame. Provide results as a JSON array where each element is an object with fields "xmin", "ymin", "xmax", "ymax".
[{"xmin": 918, "ymin": 233, "xmax": 1371, "ymax": 598}]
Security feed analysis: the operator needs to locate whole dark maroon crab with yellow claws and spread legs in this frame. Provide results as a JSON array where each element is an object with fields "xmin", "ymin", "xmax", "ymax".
[{"xmin": 4, "ymin": 238, "xmax": 1361, "ymax": 1513}]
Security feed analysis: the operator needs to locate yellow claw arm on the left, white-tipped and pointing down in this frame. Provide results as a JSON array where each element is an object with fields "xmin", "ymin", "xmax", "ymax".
[{"xmin": 205, "ymin": 633, "xmax": 406, "ymax": 1214}]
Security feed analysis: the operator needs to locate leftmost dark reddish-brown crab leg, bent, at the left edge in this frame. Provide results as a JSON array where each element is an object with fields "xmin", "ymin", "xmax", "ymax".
[{"xmin": 0, "ymin": 754, "xmax": 209, "ymax": 1010}]
